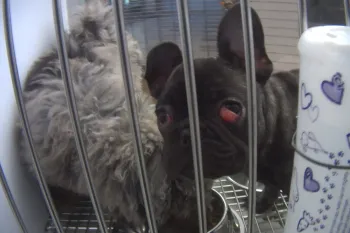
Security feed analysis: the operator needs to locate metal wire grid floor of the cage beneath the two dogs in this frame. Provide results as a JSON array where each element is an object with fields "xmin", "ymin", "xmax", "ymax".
[{"xmin": 46, "ymin": 178, "xmax": 288, "ymax": 233}]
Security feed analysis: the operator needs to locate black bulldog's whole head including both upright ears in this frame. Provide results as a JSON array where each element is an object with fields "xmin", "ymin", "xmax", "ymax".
[{"xmin": 145, "ymin": 4, "xmax": 272, "ymax": 179}]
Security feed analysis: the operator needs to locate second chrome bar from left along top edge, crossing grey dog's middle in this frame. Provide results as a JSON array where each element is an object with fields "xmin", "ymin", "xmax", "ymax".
[{"xmin": 52, "ymin": 0, "xmax": 108, "ymax": 233}]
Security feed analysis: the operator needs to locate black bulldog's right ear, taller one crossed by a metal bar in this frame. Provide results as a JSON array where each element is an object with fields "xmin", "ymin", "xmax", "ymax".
[{"xmin": 217, "ymin": 4, "xmax": 273, "ymax": 84}]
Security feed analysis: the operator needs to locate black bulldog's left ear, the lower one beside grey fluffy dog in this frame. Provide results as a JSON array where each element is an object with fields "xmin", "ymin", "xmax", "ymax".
[{"xmin": 145, "ymin": 42, "xmax": 182, "ymax": 99}]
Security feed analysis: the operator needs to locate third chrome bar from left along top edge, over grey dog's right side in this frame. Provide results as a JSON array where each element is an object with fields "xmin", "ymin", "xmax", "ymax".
[{"xmin": 112, "ymin": 0, "xmax": 158, "ymax": 233}]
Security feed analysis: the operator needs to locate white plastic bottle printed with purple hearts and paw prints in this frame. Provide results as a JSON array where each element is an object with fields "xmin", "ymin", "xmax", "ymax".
[{"xmin": 284, "ymin": 26, "xmax": 350, "ymax": 233}]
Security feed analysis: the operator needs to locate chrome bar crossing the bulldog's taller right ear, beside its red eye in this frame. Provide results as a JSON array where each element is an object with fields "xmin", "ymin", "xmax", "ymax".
[{"xmin": 241, "ymin": 0, "xmax": 258, "ymax": 233}]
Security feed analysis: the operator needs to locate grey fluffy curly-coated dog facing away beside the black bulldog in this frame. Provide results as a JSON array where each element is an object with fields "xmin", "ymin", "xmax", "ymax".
[{"xmin": 19, "ymin": 1, "xmax": 212, "ymax": 231}]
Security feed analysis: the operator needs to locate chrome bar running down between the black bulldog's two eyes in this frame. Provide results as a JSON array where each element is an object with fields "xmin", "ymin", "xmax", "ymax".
[{"xmin": 177, "ymin": 0, "xmax": 207, "ymax": 233}]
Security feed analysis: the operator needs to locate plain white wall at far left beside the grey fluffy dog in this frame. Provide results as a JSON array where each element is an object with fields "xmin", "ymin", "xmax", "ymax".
[{"xmin": 0, "ymin": 0, "xmax": 71, "ymax": 233}]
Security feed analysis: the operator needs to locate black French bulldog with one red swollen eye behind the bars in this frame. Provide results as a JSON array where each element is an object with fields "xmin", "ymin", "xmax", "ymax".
[{"xmin": 145, "ymin": 4, "xmax": 299, "ymax": 213}]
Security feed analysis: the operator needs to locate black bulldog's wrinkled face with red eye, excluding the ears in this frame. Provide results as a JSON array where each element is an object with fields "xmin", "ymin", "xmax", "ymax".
[{"xmin": 156, "ymin": 59, "xmax": 246, "ymax": 178}]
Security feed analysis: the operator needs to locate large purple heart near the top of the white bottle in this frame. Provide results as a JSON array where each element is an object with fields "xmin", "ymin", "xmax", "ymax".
[{"xmin": 321, "ymin": 72, "xmax": 344, "ymax": 105}]
